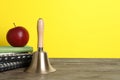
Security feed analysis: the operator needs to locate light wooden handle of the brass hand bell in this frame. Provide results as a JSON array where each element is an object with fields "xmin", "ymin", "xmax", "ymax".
[{"xmin": 37, "ymin": 18, "xmax": 44, "ymax": 50}]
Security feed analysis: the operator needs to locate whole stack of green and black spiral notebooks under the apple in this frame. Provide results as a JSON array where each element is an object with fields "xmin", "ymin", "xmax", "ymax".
[{"xmin": 0, "ymin": 46, "xmax": 33, "ymax": 72}]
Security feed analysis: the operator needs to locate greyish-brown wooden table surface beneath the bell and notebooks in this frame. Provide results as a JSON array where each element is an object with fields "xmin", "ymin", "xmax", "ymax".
[{"xmin": 0, "ymin": 58, "xmax": 120, "ymax": 80}]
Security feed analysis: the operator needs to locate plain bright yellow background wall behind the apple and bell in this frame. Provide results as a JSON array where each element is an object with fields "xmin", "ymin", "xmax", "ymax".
[{"xmin": 0, "ymin": 0, "xmax": 120, "ymax": 58}]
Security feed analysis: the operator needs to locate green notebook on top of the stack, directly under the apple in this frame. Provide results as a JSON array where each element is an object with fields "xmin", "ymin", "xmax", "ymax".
[{"xmin": 0, "ymin": 46, "xmax": 33, "ymax": 53}]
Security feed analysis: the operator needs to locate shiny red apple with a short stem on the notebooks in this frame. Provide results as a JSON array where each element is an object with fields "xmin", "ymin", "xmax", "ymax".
[{"xmin": 6, "ymin": 26, "xmax": 29, "ymax": 47}]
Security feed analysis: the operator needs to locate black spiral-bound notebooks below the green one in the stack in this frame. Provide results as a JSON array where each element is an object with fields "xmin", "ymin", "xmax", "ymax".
[{"xmin": 0, "ymin": 53, "xmax": 32, "ymax": 72}]
